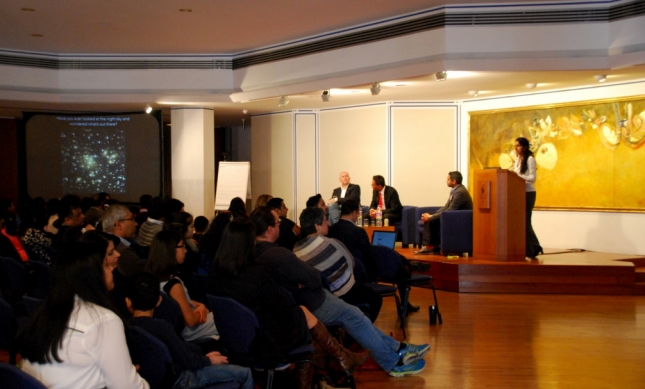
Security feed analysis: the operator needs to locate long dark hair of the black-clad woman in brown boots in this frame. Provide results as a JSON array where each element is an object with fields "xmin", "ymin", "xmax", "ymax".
[{"xmin": 211, "ymin": 218, "xmax": 255, "ymax": 276}]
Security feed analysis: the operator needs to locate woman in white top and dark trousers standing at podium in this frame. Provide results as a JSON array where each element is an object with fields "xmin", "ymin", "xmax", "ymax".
[{"xmin": 513, "ymin": 138, "xmax": 544, "ymax": 259}]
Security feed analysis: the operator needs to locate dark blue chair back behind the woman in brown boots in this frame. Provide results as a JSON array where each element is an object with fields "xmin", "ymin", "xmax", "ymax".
[{"xmin": 208, "ymin": 294, "xmax": 260, "ymax": 355}]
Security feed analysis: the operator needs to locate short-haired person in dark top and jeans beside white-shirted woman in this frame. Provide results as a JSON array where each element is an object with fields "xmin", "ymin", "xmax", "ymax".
[{"xmin": 125, "ymin": 273, "xmax": 253, "ymax": 389}]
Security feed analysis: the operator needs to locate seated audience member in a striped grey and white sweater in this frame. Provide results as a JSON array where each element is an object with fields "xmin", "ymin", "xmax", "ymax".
[{"xmin": 293, "ymin": 208, "xmax": 383, "ymax": 323}]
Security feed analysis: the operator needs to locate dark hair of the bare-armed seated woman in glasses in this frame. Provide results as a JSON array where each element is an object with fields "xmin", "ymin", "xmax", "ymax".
[{"xmin": 146, "ymin": 230, "xmax": 183, "ymax": 282}]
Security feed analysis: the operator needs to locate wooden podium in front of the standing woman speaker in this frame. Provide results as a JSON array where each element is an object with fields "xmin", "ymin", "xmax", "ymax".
[{"xmin": 473, "ymin": 169, "xmax": 526, "ymax": 261}]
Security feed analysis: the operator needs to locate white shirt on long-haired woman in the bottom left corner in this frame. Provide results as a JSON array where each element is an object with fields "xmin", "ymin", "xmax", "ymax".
[{"xmin": 22, "ymin": 297, "xmax": 150, "ymax": 389}]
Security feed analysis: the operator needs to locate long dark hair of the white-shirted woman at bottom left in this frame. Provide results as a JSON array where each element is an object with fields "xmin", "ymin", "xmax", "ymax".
[{"xmin": 18, "ymin": 242, "xmax": 112, "ymax": 364}]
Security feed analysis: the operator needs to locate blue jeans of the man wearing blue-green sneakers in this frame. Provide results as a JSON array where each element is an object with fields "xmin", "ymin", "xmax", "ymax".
[{"xmin": 312, "ymin": 290, "xmax": 401, "ymax": 372}]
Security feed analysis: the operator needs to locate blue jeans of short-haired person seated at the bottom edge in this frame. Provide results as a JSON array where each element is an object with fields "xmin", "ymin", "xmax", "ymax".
[{"xmin": 173, "ymin": 365, "xmax": 253, "ymax": 389}]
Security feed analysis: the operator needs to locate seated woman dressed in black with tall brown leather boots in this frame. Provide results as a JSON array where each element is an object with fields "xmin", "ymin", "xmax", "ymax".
[{"xmin": 209, "ymin": 219, "xmax": 369, "ymax": 388}]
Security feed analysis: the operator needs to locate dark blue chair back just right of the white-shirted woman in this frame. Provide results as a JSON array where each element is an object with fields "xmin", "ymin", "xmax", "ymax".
[{"xmin": 128, "ymin": 326, "xmax": 176, "ymax": 389}]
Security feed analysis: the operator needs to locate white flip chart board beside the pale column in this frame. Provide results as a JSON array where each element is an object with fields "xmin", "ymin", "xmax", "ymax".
[{"xmin": 215, "ymin": 162, "xmax": 251, "ymax": 211}]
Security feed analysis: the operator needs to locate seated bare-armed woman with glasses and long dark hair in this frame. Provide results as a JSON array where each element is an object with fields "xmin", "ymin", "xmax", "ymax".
[{"xmin": 146, "ymin": 230, "xmax": 219, "ymax": 341}]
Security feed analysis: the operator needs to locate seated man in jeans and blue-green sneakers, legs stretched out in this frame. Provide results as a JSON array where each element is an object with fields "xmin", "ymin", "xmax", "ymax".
[{"xmin": 251, "ymin": 207, "xmax": 430, "ymax": 377}]
